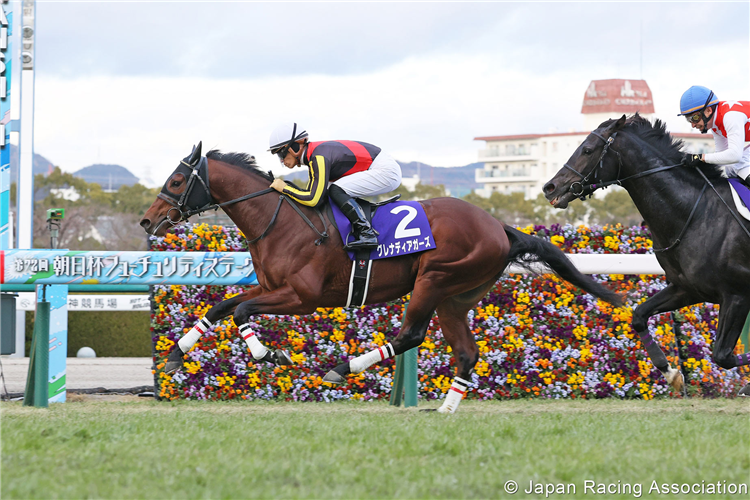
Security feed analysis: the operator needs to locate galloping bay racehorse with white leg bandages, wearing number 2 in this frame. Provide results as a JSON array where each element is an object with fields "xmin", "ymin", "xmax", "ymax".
[{"xmin": 140, "ymin": 144, "xmax": 622, "ymax": 413}]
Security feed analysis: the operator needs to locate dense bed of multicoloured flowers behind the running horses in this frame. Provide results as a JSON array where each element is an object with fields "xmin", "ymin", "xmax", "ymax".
[{"xmin": 152, "ymin": 224, "xmax": 750, "ymax": 401}]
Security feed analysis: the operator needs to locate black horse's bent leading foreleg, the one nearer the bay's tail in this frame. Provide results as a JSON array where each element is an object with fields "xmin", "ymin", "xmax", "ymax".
[{"xmin": 633, "ymin": 283, "xmax": 697, "ymax": 392}]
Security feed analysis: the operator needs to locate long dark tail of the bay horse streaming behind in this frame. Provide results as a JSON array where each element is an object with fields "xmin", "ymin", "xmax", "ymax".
[{"xmin": 503, "ymin": 224, "xmax": 625, "ymax": 306}]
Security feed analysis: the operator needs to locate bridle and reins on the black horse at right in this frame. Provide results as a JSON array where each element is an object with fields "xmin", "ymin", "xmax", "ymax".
[{"xmin": 563, "ymin": 132, "xmax": 750, "ymax": 252}]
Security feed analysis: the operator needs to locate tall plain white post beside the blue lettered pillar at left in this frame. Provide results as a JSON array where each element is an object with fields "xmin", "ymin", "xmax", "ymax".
[{"xmin": 18, "ymin": 0, "xmax": 35, "ymax": 248}]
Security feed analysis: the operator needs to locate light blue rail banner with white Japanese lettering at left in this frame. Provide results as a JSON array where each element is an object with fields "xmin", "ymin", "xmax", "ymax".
[{"xmin": 0, "ymin": 250, "xmax": 258, "ymax": 285}]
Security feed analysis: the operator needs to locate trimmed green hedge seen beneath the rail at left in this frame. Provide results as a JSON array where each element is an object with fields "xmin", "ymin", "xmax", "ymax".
[{"xmin": 26, "ymin": 311, "xmax": 151, "ymax": 358}]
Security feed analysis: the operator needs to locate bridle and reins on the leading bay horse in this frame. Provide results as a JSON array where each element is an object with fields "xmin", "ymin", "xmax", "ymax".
[{"xmin": 154, "ymin": 157, "xmax": 328, "ymax": 246}]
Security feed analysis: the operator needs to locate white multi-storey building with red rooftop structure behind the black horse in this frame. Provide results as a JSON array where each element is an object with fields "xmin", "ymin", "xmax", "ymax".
[{"xmin": 474, "ymin": 80, "xmax": 713, "ymax": 198}]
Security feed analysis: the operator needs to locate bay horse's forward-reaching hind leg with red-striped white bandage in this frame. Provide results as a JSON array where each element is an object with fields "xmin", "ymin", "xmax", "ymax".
[{"xmin": 323, "ymin": 288, "xmax": 435, "ymax": 384}]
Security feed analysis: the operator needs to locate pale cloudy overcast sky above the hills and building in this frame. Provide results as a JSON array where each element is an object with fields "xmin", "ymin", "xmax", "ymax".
[{"xmin": 22, "ymin": 0, "xmax": 750, "ymax": 184}]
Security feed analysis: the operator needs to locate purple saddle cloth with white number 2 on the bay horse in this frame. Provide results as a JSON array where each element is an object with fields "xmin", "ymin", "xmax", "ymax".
[{"xmin": 331, "ymin": 201, "xmax": 435, "ymax": 260}]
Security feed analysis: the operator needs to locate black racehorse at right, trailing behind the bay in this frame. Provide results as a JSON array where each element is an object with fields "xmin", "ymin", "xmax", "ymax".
[{"xmin": 544, "ymin": 114, "xmax": 750, "ymax": 393}]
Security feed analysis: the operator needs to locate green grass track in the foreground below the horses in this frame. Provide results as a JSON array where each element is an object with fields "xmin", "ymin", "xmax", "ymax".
[{"xmin": 0, "ymin": 397, "xmax": 750, "ymax": 499}]
